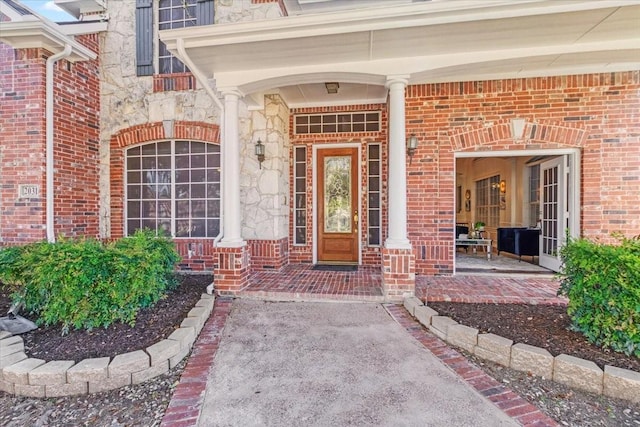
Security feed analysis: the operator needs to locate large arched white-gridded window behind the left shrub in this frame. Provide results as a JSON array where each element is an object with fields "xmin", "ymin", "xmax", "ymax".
[{"xmin": 125, "ymin": 140, "xmax": 220, "ymax": 238}]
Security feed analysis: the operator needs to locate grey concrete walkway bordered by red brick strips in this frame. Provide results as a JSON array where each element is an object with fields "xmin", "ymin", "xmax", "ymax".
[{"xmin": 198, "ymin": 300, "xmax": 518, "ymax": 427}]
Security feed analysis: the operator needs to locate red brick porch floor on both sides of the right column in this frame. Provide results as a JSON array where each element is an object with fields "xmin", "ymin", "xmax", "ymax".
[{"xmin": 238, "ymin": 264, "xmax": 566, "ymax": 305}]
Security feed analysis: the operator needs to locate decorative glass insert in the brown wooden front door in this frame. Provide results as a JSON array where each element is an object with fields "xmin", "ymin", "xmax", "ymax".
[{"xmin": 324, "ymin": 156, "xmax": 352, "ymax": 233}]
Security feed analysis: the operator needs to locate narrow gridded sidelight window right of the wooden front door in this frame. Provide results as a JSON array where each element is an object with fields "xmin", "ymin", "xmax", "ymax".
[{"xmin": 367, "ymin": 144, "xmax": 382, "ymax": 246}]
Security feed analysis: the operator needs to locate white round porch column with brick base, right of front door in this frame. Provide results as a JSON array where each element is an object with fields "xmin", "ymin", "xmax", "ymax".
[{"xmin": 382, "ymin": 76, "xmax": 416, "ymax": 301}]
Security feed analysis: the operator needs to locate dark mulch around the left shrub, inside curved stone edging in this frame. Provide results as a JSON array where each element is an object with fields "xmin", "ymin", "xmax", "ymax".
[{"xmin": 0, "ymin": 275, "xmax": 212, "ymax": 362}]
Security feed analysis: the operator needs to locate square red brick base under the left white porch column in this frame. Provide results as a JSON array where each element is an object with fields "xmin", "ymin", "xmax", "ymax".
[{"xmin": 213, "ymin": 245, "xmax": 251, "ymax": 296}]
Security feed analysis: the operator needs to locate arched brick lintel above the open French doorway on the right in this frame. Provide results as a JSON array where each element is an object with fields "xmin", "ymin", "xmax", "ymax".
[{"xmin": 449, "ymin": 120, "xmax": 588, "ymax": 152}]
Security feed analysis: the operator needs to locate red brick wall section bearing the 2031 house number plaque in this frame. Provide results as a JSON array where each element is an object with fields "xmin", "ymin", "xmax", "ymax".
[{"xmin": 0, "ymin": 35, "xmax": 100, "ymax": 244}]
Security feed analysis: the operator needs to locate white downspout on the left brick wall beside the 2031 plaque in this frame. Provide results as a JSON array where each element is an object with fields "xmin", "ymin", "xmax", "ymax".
[{"xmin": 45, "ymin": 44, "xmax": 72, "ymax": 243}]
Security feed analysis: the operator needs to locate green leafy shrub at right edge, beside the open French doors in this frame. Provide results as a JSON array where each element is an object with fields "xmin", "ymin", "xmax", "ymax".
[{"xmin": 558, "ymin": 237, "xmax": 640, "ymax": 357}]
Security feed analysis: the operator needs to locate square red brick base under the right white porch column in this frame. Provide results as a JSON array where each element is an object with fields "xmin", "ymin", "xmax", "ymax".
[{"xmin": 382, "ymin": 248, "xmax": 416, "ymax": 302}]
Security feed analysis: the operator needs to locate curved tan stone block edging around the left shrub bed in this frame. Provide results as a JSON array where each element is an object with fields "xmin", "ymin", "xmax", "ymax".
[{"xmin": 0, "ymin": 294, "xmax": 215, "ymax": 398}]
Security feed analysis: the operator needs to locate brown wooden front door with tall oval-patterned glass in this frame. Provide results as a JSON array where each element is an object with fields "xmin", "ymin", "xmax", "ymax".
[{"xmin": 316, "ymin": 148, "xmax": 360, "ymax": 263}]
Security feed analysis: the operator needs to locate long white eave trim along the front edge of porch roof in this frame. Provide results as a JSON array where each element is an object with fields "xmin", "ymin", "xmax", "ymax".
[{"xmin": 159, "ymin": 0, "xmax": 630, "ymax": 52}]
